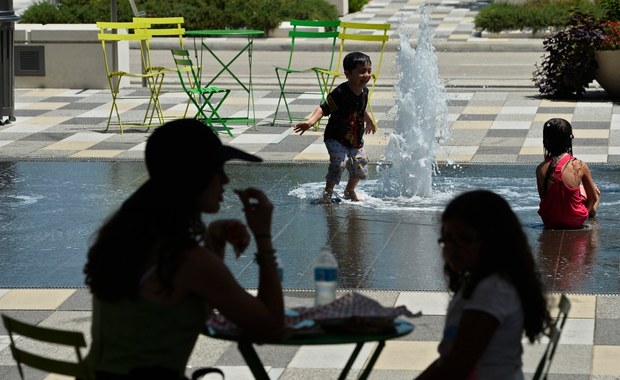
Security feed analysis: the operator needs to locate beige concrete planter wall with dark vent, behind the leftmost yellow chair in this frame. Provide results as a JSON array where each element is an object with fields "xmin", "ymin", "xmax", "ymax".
[{"xmin": 14, "ymin": 23, "xmax": 129, "ymax": 89}]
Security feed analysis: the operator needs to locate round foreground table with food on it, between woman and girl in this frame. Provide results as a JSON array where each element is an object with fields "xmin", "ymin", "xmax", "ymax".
[{"xmin": 204, "ymin": 318, "xmax": 413, "ymax": 380}]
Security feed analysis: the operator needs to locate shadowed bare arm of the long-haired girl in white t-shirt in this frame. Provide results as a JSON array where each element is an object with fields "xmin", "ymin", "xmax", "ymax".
[{"xmin": 417, "ymin": 310, "xmax": 499, "ymax": 380}]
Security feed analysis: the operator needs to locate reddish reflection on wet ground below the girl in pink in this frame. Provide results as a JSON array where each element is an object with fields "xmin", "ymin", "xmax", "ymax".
[{"xmin": 538, "ymin": 220, "xmax": 600, "ymax": 291}]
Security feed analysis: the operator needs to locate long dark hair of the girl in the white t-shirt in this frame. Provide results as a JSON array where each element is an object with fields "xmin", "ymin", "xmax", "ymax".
[{"xmin": 441, "ymin": 190, "xmax": 550, "ymax": 342}]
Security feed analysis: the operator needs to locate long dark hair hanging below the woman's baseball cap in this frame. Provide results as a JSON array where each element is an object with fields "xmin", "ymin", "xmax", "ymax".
[{"xmin": 84, "ymin": 184, "xmax": 205, "ymax": 302}]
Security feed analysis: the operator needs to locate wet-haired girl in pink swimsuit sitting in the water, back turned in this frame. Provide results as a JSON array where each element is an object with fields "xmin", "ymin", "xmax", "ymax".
[{"xmin": 536, "ymin": 118, "xmax": 600, "ymax": 229}]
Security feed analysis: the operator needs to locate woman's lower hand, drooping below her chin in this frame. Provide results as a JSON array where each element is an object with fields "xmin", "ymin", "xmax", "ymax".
[{"xmin": 205, "ymin": 219, "xmax": 250, "ymax": 257}]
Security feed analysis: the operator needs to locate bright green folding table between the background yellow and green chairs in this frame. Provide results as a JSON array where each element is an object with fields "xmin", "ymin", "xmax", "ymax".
[{"xmin": 185, "ymin": 29, "xmax": 265, "ymax": 127}]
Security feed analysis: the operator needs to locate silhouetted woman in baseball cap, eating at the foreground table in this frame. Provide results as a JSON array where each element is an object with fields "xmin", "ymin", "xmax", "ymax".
[{"xmin": 84, "ymin": 119, "xmax": 284, "ymax": 379}]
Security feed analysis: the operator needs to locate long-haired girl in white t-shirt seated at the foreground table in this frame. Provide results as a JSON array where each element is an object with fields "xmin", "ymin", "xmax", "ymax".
[{"xmin": 418, "ymin": 190, "xmax": 550, "ymax": 380}]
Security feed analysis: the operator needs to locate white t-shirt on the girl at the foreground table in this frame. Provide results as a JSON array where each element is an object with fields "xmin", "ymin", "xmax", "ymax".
[{"xmin": 438, "ymin": 274, "xmax": 523, "ymax": 380}]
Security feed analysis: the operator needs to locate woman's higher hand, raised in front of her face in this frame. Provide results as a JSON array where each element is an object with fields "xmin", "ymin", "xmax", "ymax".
[{"xmin": 235, "ymin": 187, "xmax": 273, "ymax": 238}]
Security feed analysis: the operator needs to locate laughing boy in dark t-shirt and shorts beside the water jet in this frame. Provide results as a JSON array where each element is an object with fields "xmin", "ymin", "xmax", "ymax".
[{"xmin": 293, "ymin": 52, "xmax": 377, "ymax": 204}]
